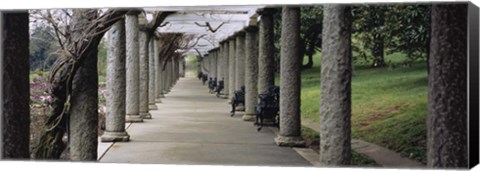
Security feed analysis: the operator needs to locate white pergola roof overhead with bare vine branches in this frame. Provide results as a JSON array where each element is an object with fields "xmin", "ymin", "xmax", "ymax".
[{"xmin": 144, "ymin": 5, "xmax": 265, "ymax": 55}]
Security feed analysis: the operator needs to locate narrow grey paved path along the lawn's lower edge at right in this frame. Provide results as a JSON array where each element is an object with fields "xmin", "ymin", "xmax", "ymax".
[{"xmin": 302, "ymin": 119, "xmax": 425, "ymax": 168}]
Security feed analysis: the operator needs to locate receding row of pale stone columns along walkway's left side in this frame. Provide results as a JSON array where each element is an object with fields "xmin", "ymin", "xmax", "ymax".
[{"xmin": 101, "ymin": 11, "xmax": 180, "ymax": 142}]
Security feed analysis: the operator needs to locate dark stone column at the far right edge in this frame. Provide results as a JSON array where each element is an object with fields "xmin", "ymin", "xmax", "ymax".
[{"xmin": 427, "ymin": 4, "xmax": 468, "ymax": 168}]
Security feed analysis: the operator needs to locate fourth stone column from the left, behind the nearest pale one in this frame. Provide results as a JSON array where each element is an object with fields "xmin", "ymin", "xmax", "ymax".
[{"xmin": 125, "ymin": 12, "xmax": 143, "ymax": 122}]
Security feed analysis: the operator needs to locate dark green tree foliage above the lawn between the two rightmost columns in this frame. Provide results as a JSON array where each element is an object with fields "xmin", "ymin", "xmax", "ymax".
[{"xmin": 352, "ymin": 4, "xmax": 430, "ymax": 64}]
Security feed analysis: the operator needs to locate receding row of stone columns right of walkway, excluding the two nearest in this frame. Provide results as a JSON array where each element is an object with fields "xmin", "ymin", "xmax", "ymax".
[{"xmin": 201, "ymin": 7, "xmax": 304, "ymax": 146}]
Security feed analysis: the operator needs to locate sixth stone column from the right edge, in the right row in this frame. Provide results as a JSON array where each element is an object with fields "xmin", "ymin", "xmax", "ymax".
[{"xmin": 235, "ymin": 31, "xmax": 245, "ymax": 90}]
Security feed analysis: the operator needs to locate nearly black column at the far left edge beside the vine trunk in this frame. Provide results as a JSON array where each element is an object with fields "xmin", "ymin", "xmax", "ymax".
[{"xmin": 0, "ymin": 11, "xmax": 30, "ymax": 159}]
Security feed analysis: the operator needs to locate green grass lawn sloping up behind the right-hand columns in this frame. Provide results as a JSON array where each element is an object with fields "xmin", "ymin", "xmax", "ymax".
[{"xmin": 276, "ymin": 53, "xmax": 428, "ymax": 163}]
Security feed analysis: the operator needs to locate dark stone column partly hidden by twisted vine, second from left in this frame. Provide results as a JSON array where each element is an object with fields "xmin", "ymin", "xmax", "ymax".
[{"xmin": 69, "ymin": 9, "xmax": 98, "ymax": 161}]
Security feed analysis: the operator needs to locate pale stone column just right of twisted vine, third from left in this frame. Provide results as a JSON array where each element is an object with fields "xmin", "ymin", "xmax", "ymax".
[{"xmin": 101, "ymin": 20, "xmax": 130, "ymax": 142}]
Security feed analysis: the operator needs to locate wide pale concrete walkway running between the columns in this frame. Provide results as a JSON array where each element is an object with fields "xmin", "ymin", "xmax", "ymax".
[{"xmin": 99, "ymin": 77, "xmax": 312, "ymax": 166}]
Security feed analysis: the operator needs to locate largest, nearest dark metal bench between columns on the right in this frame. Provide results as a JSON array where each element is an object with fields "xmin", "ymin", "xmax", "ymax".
[{"xmin": 253, "ymin": 86, "xmax": 280, "ymax": 131}]
